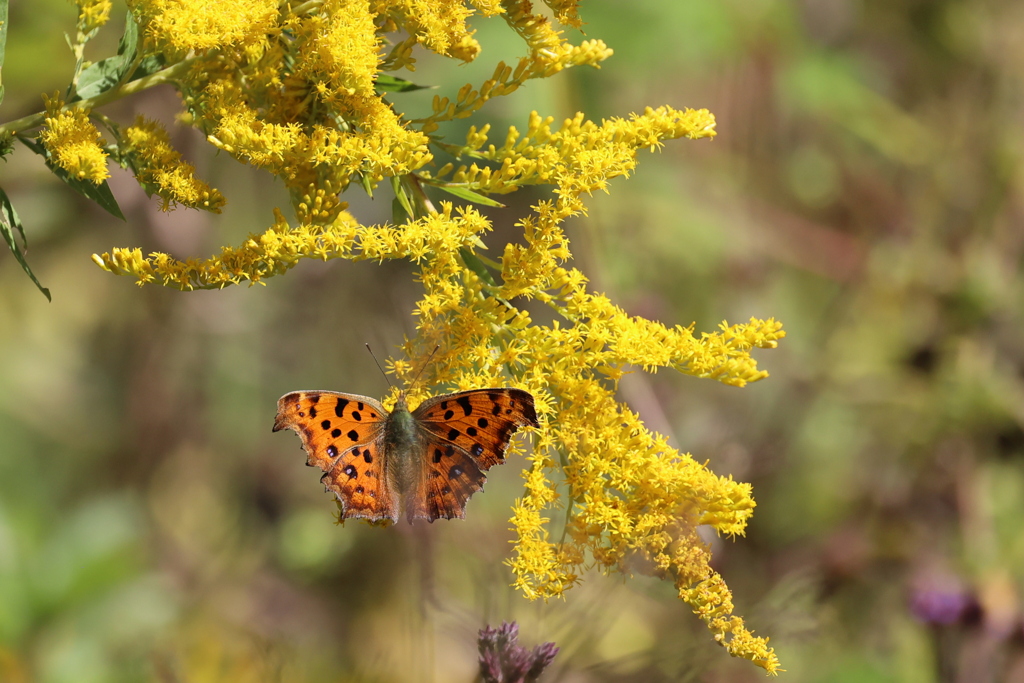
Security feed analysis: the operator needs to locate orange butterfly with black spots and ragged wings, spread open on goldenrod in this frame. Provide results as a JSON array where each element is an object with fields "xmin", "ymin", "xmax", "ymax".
[{"xmin": 273, "ymin": 388, "xmax": 538, "ymax": 523}]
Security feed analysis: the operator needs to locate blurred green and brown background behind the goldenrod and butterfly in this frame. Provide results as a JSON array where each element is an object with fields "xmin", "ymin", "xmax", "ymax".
[{"xmin": 0, "ymin": 0, "xmax": 1024, "ymax": 683}]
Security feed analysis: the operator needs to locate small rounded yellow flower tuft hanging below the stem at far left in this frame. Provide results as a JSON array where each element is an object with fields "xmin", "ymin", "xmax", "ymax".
[{"xmin": 39, "ymin": 95, "xmax": 111, "ymax": 185}]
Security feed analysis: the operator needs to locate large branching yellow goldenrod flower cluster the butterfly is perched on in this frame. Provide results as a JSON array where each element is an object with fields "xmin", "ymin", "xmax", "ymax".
[{"xmin": 74, "ymin": 0, "xmax": 784, "ymax": 674}]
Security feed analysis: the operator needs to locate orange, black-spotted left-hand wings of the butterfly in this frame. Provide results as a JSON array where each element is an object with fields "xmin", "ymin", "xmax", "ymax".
[{"xmin": 273, "ymin": 391, "xmax": 398, "ymax": 522}]
